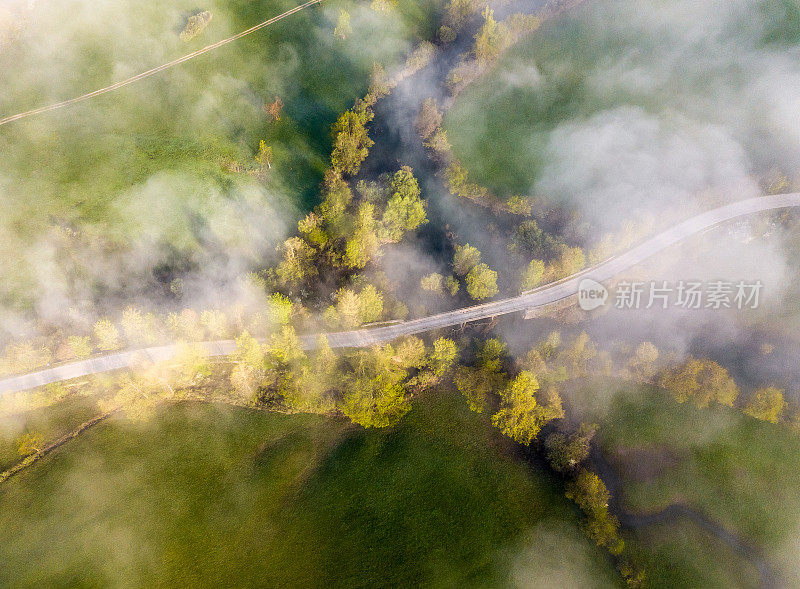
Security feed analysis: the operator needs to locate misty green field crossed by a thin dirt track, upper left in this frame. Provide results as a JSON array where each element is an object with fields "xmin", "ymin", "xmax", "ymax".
[{"xmin": 0, "ymin": 0, "xmax": 436, "ymax": 314}]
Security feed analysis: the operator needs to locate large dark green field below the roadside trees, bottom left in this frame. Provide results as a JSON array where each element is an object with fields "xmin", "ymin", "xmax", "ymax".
[{"xmin": 0, "ymin": 395, "xmax": 616, "ymax": 587}]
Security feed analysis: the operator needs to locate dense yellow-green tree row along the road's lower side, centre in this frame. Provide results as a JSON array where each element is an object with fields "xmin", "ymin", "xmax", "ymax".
[{"xmin": 230, "ymin": 326, "xmax": 458, "ymax": 427}]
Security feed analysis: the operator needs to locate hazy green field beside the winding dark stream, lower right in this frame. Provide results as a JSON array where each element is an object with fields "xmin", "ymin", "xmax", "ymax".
[{"xmin": 567, "ymin": 381, "xmax": 800, "ymax": 586}]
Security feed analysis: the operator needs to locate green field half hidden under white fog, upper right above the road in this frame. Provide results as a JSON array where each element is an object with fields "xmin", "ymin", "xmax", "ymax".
[{"xmin": 445, "ymin": 0, "xmax": 800, "ymax": 207}]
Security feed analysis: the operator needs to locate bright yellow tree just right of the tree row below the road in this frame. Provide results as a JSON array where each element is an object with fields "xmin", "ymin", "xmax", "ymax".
[{"xmin": 492, "ymin": 370, "xmax": 564, "ymax": 444}]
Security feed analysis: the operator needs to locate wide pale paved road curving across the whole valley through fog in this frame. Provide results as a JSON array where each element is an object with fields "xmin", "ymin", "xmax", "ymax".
[{"xmin": 0, "ymin": 193, "xmax": 800, "ymax": 394}]
